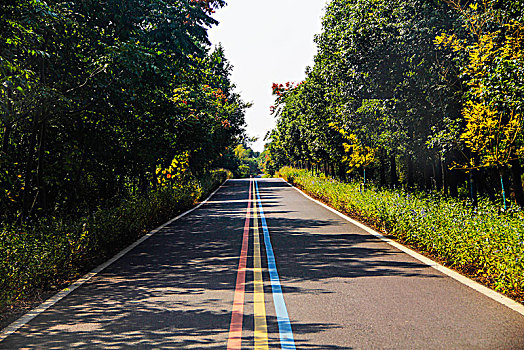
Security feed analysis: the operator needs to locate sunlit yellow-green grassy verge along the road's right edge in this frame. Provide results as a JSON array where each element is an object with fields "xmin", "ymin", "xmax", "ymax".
[{"xmin": 278, "ymin": 167, "xmax": 524, "ymax": 302}]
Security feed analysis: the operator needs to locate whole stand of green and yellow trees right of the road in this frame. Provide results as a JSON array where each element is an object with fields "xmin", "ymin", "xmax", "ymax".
[{"xmin": 264, "ymin": 0, "xmax": 524, "ymax": 205}]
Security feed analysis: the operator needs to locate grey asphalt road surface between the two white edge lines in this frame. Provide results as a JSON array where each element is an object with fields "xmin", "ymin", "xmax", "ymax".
[{"xmin": 0, "ymin": 179, "xmax": 524, "ymax": 349}]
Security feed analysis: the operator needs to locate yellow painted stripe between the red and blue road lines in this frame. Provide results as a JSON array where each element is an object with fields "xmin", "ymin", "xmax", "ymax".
[{"xmin": 253, "ymin": 183, "xmax": 269, "ymax": 350}]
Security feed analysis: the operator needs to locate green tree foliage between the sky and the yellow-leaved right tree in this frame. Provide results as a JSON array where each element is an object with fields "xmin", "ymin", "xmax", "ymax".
[{"xmin": 268, "ymin": 0, "xmax": 460, "ymax": 186}]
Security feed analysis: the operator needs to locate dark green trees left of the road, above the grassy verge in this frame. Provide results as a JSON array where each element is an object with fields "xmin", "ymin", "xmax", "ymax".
[{"xmin": 0, "ymin": 0, "xmax": 248, "ymax": 224}]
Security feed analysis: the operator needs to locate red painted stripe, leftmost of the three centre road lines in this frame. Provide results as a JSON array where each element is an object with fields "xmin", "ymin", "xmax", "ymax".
[{"xmin": 227, "ymin": 180, "xmax": 252, "ymax": 350}]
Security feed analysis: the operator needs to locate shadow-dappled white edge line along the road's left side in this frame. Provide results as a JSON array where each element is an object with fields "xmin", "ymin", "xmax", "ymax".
[{"xmin": 0, "ymin": 180, "xmax": 229, "ymax": 342}]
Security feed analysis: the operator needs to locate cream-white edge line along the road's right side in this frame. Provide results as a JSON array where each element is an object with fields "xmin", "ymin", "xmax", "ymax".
[{"xmin": 282, "ymin": 179, "xmax": 524, "ymax": 316}]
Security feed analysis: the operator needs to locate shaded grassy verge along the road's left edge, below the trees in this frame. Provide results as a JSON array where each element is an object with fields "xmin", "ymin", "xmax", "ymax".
[{"xmin": 0, "ymin": 170, "xmax": 232, "ymax": 311}]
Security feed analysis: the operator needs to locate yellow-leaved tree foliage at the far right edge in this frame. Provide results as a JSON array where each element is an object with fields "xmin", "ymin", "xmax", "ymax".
[{"xmin": 435, "ymin": 0, "xmax": 524, "ymax": 168}]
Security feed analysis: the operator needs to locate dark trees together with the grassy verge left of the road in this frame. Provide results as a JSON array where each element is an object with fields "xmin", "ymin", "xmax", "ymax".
[{"xmin": 0, "ymin": 0, "xmax": 258, "ymax": 308}]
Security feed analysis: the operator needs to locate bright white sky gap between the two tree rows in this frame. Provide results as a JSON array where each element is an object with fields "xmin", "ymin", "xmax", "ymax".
[{"xmin": 209, "ymin": 0, "xmax": 327, "ymax": 152}]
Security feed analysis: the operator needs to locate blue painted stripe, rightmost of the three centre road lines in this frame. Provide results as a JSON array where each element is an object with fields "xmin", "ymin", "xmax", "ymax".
[{"xmin": 255, "ymin": 180, "xmax": 296, "ymax": 350}]
